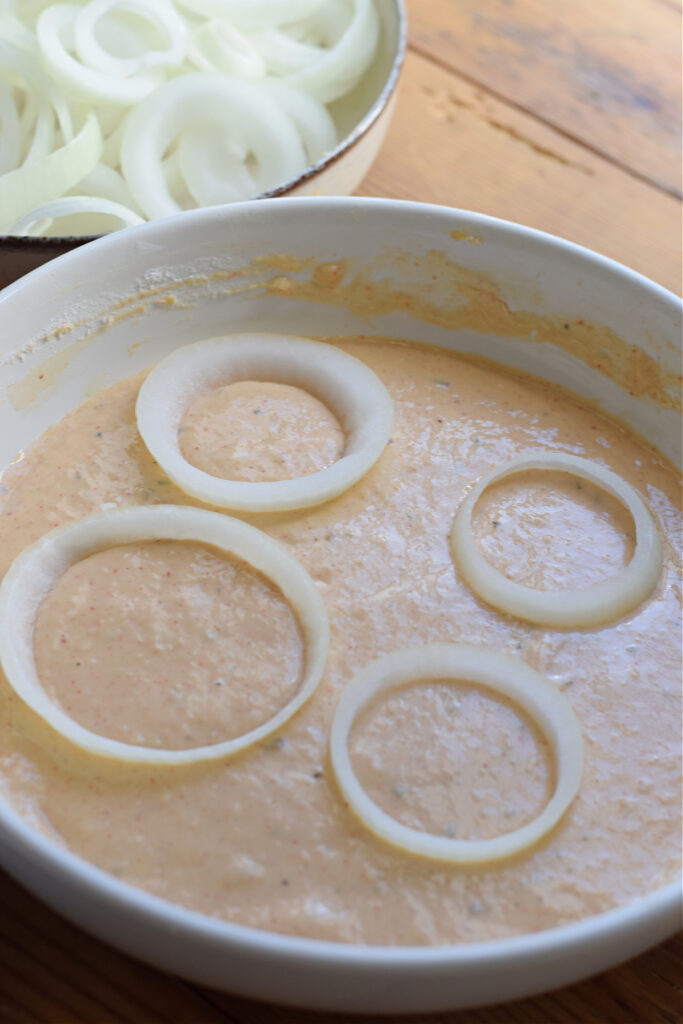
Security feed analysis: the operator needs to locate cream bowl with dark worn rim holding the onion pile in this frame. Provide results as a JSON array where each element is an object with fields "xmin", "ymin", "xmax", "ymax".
[{"xmin": 0, "ymin": 0, "xmax": 408, "ymax": 288}]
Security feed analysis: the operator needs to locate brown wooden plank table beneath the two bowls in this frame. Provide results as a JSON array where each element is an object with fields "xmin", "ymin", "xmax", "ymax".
[{"xmin": 0, "ymin": 0, "xmax": 683, "ymax": 1024}]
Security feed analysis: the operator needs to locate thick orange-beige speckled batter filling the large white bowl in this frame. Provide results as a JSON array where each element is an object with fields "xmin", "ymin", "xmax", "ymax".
[{"xmin": 0, "ymin": 337, "xmax": 681, "ymax": 945}]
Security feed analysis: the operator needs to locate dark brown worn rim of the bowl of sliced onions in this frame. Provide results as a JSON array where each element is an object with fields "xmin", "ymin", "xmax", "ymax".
[{"xmin": 0, "ymin": 0, "xmax": 408, "ymax": 246}]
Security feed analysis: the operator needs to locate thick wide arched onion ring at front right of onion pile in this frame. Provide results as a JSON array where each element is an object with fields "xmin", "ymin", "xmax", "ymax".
[{"xmin": 121, "ymin": 72, "xmax": 306, "ymax": 217}]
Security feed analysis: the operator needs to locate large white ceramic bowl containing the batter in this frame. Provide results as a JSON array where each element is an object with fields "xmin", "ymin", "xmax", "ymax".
[{"xmin": 0, "ymin": 199, "xmax": 681, "ymax": 1013}]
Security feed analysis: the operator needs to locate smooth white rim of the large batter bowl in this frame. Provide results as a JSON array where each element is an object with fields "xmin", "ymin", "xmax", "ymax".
[{"xmin": 0, "ymin": 197, "xmax": 682, "ymax": 974}]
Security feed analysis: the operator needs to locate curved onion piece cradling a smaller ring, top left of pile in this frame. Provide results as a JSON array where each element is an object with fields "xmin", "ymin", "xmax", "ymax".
[{"xmin": 36, "ymin": 3, "xmax": 164, "ymax": 106}]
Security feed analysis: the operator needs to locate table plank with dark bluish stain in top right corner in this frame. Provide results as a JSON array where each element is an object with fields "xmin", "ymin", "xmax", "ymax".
[{"xmin": 408, "ymin": 0, "xmax": 681, "ymax": 195}]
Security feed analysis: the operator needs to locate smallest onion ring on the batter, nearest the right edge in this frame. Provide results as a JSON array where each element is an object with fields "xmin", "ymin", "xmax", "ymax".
[{"xmin": 451, "ymin": 453, "xmax": 661, "ymax": 628}]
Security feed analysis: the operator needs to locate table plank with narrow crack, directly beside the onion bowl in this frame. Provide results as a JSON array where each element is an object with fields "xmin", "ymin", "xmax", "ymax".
[{"xmin": 359, "ymin": 53, "xmax": 681, "ymax": 292}]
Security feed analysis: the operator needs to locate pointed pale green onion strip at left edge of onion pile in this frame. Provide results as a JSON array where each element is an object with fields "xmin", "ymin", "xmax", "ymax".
[{"xmin": 0, "ymin": 113, "xmax": 102, "ymax": 230}]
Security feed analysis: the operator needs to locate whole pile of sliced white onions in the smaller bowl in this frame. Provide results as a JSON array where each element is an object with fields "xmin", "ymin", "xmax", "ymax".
[{"xmin": 0, "ymin": 0, "xmax": 380, "ymax": 234}]
